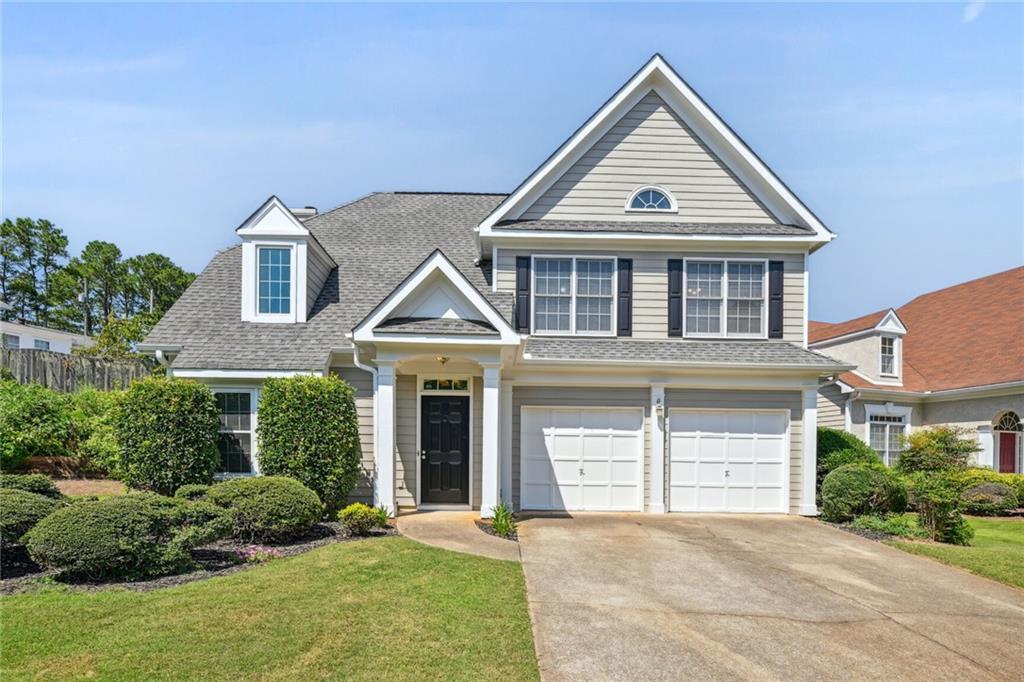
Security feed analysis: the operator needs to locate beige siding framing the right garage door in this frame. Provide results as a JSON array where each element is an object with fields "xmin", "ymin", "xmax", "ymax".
[{"xmin": 663, "ymin": 389, "xmax": 804, "ymax": 513}]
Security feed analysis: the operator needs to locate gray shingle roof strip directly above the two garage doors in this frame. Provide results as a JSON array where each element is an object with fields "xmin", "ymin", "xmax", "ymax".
[{"xmin": 523, "ymin": 336, "xmax": 848, "ymax": 371}]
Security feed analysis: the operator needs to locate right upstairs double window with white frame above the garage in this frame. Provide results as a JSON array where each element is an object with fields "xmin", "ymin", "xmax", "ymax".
[{"xmin": 686, "ymin": 260, "xmax": 767, "ymax": 338}]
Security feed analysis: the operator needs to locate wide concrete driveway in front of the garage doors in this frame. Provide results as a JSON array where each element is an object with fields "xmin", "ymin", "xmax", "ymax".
[{"xmin": 519, "ymin": 514, "xmax": 1024, "ymax": 680}]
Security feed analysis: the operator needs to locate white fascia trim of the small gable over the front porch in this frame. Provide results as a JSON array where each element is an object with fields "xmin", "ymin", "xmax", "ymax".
[{"xmin": 352, "ymin": 250, "xmax": 520, "ymax": 345}]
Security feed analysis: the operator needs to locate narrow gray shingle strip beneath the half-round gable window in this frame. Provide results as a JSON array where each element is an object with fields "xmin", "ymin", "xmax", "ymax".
[{"xmin": 494, "ymin": 220, "xmax": 814, "ymax": 237}]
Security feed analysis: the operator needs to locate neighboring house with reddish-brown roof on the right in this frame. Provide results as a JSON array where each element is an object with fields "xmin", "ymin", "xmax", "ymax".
[{"xmin": 810, "ymin": 267, "xmax": 1024, "ymax": 473}]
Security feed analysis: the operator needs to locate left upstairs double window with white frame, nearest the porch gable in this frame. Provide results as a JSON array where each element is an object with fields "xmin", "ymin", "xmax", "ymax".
[{"xmin": 534, "ymin": 257, "xmax": 615, "ymax": 336}]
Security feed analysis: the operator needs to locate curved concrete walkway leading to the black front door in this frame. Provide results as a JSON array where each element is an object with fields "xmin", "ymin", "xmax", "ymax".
[{"xmin": 397, "ymin": 511, "xmax": 519, "ymax": 561}]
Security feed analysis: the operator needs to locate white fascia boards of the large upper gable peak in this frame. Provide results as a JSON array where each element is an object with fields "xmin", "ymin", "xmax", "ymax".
[{"xmin": 477, "ymin": 54, "xmax": 836, "ymax": 244}]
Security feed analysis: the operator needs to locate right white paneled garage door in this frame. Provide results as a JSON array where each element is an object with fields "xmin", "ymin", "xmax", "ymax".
[{"xmin": 669, "ymin": 410, "xmax": 788, "ymax": 513}]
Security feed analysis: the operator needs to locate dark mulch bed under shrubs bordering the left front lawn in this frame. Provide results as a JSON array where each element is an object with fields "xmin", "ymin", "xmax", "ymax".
[{"xmin": 0, "ymin": 521, "xmax": 398, "ymax": 594}]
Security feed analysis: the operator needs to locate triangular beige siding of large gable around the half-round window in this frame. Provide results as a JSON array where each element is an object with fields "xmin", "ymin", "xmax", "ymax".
[{"xmin": 522, "ymin": 91, "xmax": 775, "ymax": 223}]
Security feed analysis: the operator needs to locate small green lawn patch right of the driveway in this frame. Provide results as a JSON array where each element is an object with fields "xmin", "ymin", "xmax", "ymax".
[{"xmin": 889, "ymin": 516, "xmax": 1024, "ymax": 588}]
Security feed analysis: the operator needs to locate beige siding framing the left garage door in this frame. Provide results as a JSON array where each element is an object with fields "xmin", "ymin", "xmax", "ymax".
[{"xmin": 512, "ymin": 386, "xmax": 650, "ymax": 509}]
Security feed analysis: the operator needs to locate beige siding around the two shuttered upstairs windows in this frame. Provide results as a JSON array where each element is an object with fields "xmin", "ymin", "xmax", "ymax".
[{"xmin": 495, "ymin": 249, "xmax": 805, "ymax": 344}]
